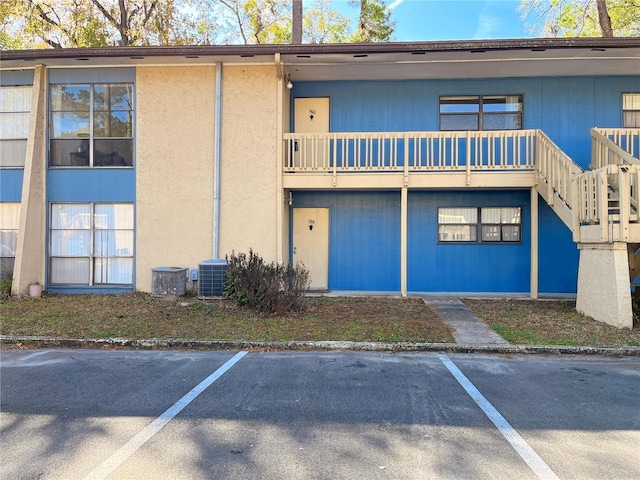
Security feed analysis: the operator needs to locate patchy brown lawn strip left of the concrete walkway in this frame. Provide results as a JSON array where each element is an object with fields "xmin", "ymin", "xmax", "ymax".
[{"xmin": 0, "ymin": 293, "xmax": 454, "ymax": 343}]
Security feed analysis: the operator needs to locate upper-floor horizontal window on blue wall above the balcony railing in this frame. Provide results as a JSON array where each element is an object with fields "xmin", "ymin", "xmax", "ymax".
[{"xmin": 440, "ymin": 95, "xmax": 522, "ymax": 130}]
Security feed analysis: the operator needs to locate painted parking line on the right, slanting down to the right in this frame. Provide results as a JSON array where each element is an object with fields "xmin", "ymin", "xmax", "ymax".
[{"xmin": 438, "ymin": 355, "xmax": 559, "ymax": 480}]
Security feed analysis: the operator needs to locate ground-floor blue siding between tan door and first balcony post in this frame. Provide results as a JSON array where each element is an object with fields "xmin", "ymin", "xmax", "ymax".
[{"xmin": 293, "ymin": 192, "xmax": 400, "ymax": 291}]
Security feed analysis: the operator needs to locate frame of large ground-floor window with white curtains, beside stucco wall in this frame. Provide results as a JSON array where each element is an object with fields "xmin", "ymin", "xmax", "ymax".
[{"xmin": 47, "ymin": 202, "xmax": 135, "ymax": 287}]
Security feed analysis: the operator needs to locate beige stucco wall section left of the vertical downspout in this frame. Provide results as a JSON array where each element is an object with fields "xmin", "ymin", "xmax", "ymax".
[{"xmin": 135, "ymin": 66, "xmax": 215, "ymax": 292}]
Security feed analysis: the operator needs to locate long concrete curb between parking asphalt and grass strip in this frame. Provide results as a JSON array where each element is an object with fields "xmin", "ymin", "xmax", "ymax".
[{"xmin": 0, "ymin": 335, "xmax": 640, "ymax": 356}]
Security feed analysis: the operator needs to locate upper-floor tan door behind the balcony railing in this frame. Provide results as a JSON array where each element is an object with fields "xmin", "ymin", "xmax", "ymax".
[{"xmin": 293, "ymin": 97, "xmax": 329, "ymax": 168}]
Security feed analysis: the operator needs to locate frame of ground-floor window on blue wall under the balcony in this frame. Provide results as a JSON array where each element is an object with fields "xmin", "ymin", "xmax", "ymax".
[{"xmin": 436, "ymin": 205, "xmax": 523, "ymax": 245}]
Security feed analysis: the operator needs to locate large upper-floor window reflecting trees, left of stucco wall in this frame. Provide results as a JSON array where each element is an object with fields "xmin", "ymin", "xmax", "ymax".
[{"xmin": 49, "ymin": 83, "xmax": 133, "ymax": 167}]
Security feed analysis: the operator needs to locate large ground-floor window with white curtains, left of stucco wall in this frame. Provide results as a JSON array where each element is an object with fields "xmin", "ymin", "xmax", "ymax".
[{"xmin": 49, "ymin": 203, "xmax": 133, "ymax": 285}]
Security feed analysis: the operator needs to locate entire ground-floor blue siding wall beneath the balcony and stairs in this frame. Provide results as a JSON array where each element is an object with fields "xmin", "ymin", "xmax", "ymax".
[{"xmin": 293, "ymin": 190, "xmax": 578, "ymax": 294}]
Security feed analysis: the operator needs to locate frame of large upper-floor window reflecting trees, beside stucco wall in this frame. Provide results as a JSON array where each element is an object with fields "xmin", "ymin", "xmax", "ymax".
[{"xmin": 47, "ymin": 81, "xmax": 135, "ymax": 169}]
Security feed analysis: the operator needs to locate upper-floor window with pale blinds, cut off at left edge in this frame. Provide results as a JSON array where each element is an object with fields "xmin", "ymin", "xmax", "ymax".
[{"xmin": 0, "ymin": 85, "xmax": 31, "ymax": 167}]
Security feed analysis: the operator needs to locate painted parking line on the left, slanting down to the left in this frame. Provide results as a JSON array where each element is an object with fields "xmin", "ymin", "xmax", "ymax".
[{"xmin": 84, "ymin": 352, "xmax": 247, "ymax": 480}]
